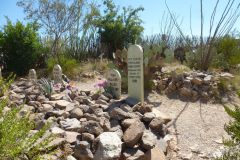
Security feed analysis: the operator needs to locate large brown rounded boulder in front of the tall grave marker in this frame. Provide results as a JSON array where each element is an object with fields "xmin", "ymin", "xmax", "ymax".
[{"xmin": 123, "ymin": 121, "xmax": 145, "ymax": 147}]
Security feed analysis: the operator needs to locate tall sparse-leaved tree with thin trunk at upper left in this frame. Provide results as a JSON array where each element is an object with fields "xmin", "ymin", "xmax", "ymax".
[{"xmin": 17, "ymin": 0, "xmax": 84, "ymax": 61}]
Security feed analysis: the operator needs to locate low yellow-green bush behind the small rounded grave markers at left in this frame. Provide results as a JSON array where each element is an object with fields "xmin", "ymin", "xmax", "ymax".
[{"xmin": 47, "ymin": 55, "xmax": 79, "ymax": 77}]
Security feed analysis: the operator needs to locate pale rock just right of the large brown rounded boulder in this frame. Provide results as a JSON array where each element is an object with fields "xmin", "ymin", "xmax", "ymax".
[{"xmin": 142, "ymin": 130, "xmax": 157, "ymax": 150}]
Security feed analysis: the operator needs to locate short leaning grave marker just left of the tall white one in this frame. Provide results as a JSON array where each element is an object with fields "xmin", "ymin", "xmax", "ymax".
[{"xmin": 107, "ymin": 69, "xmax": 121, "ymax": 99}]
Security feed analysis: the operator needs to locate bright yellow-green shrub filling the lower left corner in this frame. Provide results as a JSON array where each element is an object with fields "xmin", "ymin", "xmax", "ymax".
[{"xmin": 0, "ymin": 76, "xmax": 50, "ymax": 160}]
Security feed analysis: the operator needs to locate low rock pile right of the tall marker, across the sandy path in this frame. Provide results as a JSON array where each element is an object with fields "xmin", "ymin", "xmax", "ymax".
[{"xmin": 153, "ymin": 71, "xmax": 233, "ymax": 101}]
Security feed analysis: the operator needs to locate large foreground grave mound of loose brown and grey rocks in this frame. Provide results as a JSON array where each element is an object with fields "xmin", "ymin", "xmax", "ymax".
[{"xmin": 6, "ymin": 79, "xmax": 171, "ymax": 160}]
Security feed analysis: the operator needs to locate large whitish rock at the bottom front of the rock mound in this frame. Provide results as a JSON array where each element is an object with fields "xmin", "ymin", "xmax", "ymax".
[{"xmin": 94, "ymin": 132, "xmax": 122, "ymax": 160}]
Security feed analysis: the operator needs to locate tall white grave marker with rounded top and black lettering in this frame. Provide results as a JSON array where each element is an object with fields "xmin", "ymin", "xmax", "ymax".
[{"xmin": 128, "ymin": 45, "xmax": 144, "ymax": 104}]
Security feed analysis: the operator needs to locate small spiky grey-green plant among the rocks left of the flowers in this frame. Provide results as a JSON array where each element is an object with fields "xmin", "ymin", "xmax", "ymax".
[{"xmin": 38, "ymin": 78, "xmax": 53, "ymax": 98}]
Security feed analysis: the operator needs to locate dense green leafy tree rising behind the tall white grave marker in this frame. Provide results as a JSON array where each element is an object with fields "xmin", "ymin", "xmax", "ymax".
[{"xmin": 95, "ymin": 0, "xmax": 144, "ymax": 57}]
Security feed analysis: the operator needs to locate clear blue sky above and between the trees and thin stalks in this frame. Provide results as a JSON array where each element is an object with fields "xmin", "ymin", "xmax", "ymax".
[{"xmin": 0, "ymin": 0, "xmax": 240, "ymax": 35}]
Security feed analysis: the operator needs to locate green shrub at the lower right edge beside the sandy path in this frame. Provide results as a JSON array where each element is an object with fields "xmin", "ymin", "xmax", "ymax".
[{"xmin": 218, "ymin": 106, "xmax": 240, "ymax": 160}]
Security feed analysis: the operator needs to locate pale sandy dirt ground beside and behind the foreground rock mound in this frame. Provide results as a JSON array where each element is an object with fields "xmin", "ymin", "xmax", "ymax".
[{"xmin": 76, "ymin": 77, "xmax": 230, "ymax": 160}]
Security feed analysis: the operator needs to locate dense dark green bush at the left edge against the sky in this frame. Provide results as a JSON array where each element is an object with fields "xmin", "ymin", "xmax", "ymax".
[{"xmin": 0, "ymin": 20, "xmax": 41, "ymax": 75}]
